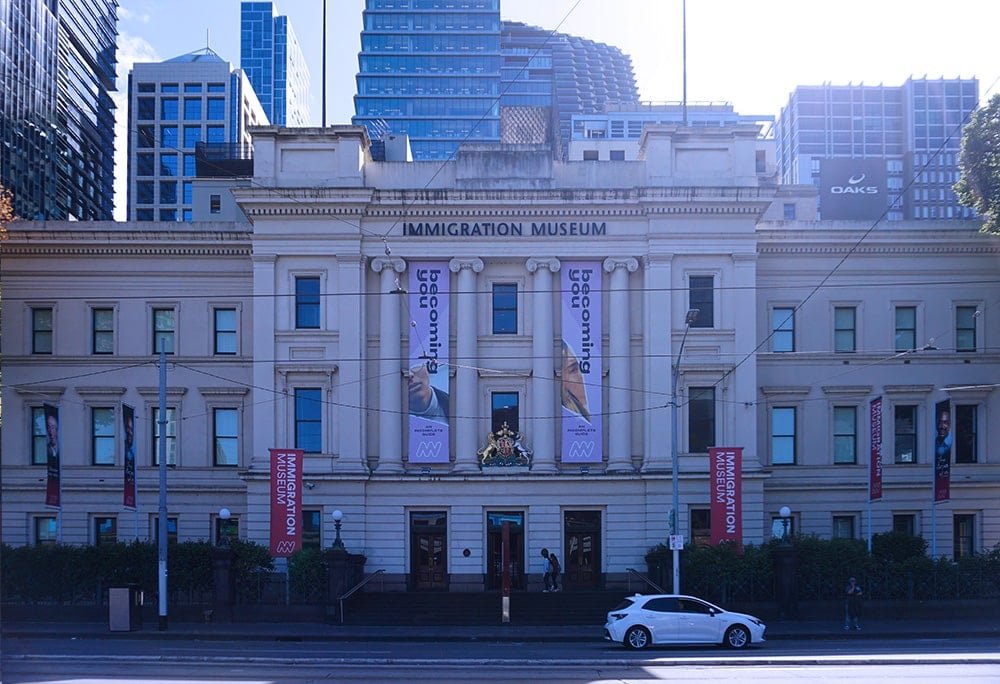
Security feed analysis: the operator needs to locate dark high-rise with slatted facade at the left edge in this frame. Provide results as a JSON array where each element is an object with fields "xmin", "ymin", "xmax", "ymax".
[{"xmin": 0, "ymin": 0, "xmax": 118, "ymax": 220}]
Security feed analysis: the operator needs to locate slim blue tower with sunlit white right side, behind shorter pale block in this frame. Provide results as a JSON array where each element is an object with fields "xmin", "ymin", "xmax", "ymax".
[{"xmin": 240, "ymin": 2, "xmax": 308, "ymax": 126}]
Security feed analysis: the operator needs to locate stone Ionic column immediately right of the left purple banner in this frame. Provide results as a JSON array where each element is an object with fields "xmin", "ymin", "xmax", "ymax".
[{"xmin": 448, "ymin": 258, "xmax": 483, "ymax": 472}]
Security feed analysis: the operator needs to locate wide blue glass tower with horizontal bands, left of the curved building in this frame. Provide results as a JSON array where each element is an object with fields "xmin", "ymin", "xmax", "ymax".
[{"xmin": 352, "ymin": 0, "xmax": 501, "ymax": 160}]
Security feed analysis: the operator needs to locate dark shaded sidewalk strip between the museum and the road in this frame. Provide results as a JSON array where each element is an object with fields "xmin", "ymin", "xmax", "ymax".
[{"xmin": 7, "ymin": 615, "xmax": 1000, "ymax": 643}]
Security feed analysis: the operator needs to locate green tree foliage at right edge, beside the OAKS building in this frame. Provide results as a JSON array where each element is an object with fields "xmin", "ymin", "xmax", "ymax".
[{"xmin": 955, "ymin": 94, "xmax": 1000, "ymax": 233}]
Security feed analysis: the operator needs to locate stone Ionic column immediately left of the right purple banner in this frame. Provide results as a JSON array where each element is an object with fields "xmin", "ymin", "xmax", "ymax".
[{"xmin": 525, "ymin": 258, "xmax": 560, "ymax": 472}]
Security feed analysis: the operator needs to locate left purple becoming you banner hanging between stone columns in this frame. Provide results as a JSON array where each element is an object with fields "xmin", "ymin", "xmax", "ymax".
[{"xmin": 407, "ymin": 261, "xmax": 451, "ymax": 463}]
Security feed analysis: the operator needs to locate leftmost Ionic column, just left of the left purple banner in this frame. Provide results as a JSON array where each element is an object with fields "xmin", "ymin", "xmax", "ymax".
[{"xmin": 372, "ymin": 257, "xmax": 406, "ymax": 473}]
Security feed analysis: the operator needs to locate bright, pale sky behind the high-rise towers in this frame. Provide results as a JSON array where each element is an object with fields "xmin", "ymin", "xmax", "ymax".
[{"xmin": 115, "ymin": 0, "xmax": 1000, "ymax": 220}]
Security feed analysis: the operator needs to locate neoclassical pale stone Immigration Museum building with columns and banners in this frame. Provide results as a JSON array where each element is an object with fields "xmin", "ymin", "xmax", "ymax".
[{"xmin": 2, "ymin": 125, "xmax": 1000, "ymax": 591}]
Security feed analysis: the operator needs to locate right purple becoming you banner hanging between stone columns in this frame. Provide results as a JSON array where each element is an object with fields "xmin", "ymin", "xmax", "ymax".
[{"xmin": 560, "ymin": 261, "xmax": 604, "ymax": 463}]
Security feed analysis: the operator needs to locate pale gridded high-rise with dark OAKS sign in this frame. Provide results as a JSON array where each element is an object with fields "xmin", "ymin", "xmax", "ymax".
[{"xmin": 775, "ymin": 78, "xmax": 979, "ymax": 221}]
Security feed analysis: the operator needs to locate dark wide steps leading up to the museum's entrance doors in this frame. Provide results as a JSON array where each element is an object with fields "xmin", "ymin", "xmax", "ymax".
[{"xmin": 344, "ymin": 591, "xmax": 625, "ymax": 628}]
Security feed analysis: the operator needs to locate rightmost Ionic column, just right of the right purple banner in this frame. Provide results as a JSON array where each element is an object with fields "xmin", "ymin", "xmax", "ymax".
[{"xmin": 604, "ymin": 257, "xmax": 639, "ymax": 473}]
